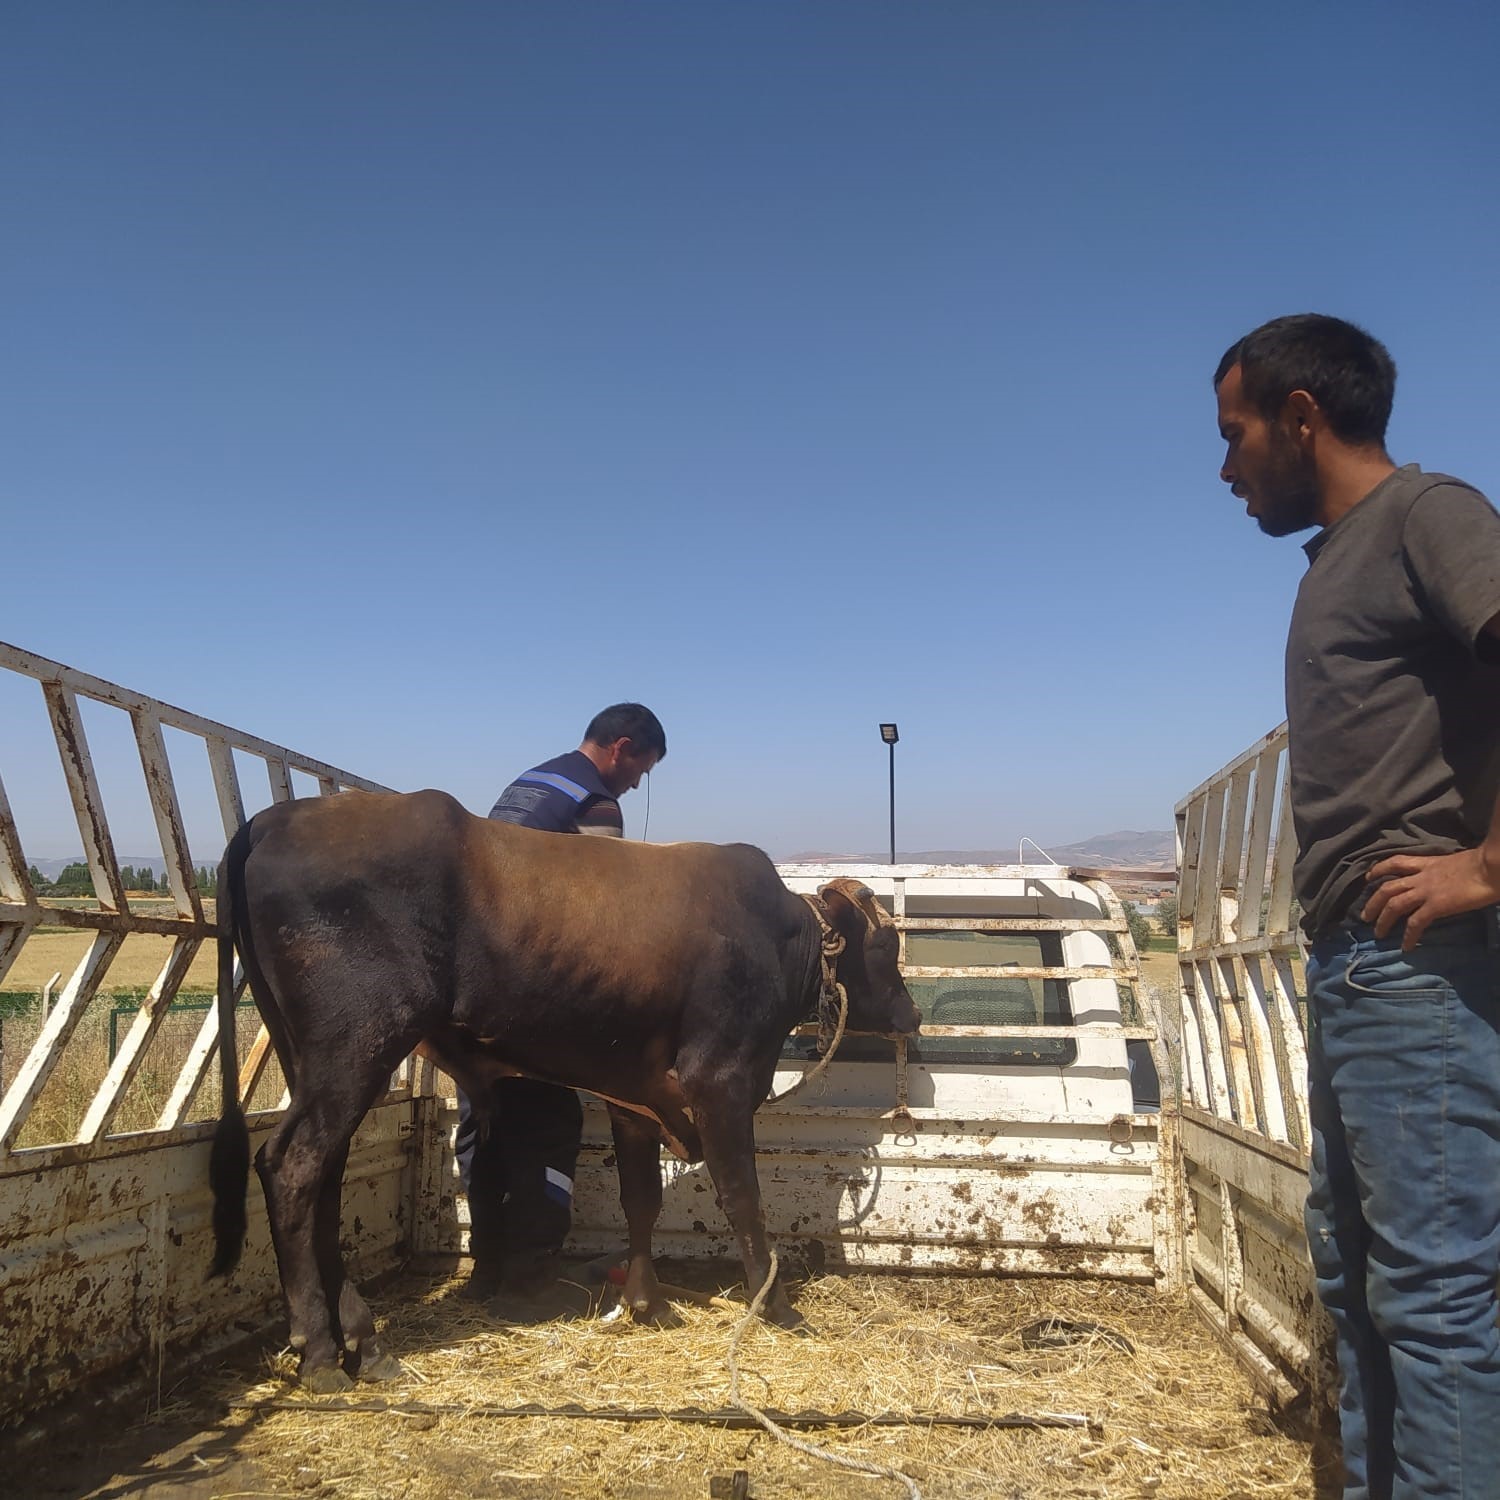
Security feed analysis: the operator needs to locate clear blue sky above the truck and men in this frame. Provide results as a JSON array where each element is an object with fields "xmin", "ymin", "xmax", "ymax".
[{"xmin": 0, "ymin": 0, "xmax": 1500, "ymax": 857}]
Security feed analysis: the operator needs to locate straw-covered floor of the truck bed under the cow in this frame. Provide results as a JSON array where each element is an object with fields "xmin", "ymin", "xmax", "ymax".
[{"xmin": 0, "ymin": 1268, "xmax": 1332, "ymax": 1500}]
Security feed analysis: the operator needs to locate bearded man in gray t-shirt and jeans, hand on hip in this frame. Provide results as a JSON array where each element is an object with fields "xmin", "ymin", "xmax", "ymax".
[{"xmin": 1214, "ymin": 314, "xmax": 1500, "ymax": 1500}]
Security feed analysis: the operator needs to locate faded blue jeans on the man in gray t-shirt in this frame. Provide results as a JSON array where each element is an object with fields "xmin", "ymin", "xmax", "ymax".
[{"xmin": 1307, "ymin": 908, "xmax": 1500, "ymax": 1500}]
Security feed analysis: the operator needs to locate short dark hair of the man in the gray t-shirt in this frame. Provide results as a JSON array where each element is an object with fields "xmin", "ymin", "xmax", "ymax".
[{"xmin": 1214, "ymin": 312, "xmax": 1397, "ymax": 447}]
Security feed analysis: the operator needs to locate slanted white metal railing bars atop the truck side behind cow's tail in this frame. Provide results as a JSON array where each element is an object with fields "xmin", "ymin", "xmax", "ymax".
[{"xmin": 0, "ymin": 642, "xmax": 384, "ymax": 1170}]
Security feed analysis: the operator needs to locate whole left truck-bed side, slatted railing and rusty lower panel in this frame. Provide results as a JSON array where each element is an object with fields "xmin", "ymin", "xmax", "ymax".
[{"xmin": 0, "ymin": 644, "xmax": 413, "ymax": 1421}]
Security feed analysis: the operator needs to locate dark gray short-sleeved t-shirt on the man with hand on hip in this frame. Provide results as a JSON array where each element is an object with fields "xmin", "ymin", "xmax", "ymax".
[{"xmin": 1287, "ymin": 464, "xmax": 1500, "ymax": 938}]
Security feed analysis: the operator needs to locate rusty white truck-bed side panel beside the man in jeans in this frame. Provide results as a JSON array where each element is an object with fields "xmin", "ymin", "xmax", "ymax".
[{"xmin": 1176, "ymin": 725, "xmax": 1331, "ymax": 1400}]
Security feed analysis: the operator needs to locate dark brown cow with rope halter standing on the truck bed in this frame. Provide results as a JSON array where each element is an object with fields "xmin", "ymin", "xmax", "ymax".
[{"xmin": 210, "ymin": 792, "xmax": 920, "ymax": 1392}]
